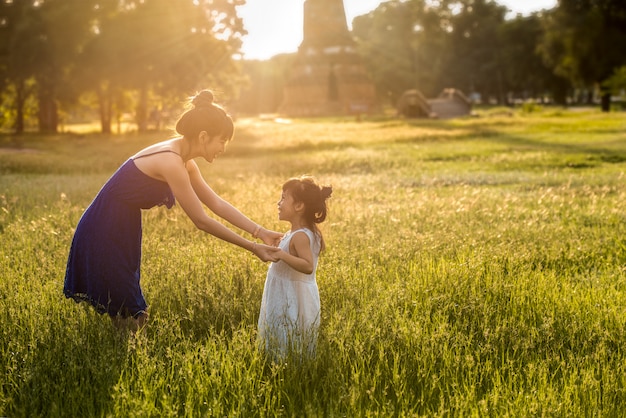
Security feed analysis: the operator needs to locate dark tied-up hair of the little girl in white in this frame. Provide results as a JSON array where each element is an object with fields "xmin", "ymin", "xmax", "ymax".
[{"xmin": 283, "ymin": 176, "xmax": 333, "ymax": 250}]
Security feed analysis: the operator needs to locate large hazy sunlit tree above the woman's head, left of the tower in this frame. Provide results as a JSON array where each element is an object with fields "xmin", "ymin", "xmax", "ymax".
[{"xmin": 74, "ymin": 0, "xmax": 244, "ymax": 132}]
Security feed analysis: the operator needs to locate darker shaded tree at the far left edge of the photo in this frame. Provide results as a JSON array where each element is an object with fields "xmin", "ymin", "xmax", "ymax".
[{"xmin": 1, "ymin": 0, "xmax": 103, "ymax": 132}]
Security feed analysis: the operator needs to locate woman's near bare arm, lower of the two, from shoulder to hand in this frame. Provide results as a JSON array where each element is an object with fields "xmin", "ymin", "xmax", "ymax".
[{"xmin": 160, "ymin": 154, "xmax": 277, "ymax": 261}]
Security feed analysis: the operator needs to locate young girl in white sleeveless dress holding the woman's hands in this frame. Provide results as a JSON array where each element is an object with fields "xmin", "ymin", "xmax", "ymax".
[{"xmin": 258, "ymin": 177, "xmax": 332, "ymax": 357}]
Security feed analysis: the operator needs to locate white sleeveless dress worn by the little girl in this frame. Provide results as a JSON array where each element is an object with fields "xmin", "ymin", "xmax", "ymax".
[{"xmin": 258, "ymin": 228, "xmax": 320, "ymax": 356}]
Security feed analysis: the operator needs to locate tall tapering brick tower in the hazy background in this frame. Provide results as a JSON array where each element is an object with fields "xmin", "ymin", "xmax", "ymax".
[{"xmin": 279, "ymin": 0, "xmax": 376, "ymax": 117}]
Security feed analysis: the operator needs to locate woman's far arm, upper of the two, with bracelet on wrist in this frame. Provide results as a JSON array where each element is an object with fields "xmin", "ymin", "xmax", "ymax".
[{"xmin": 187, "ymin": 160, "xmax": 282, "ymax": 245}]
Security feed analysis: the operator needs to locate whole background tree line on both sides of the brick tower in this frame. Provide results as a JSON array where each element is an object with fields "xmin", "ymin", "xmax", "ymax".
[{"xmin": 0, "ymin": 0, "xmax": 626, "ymax": 133}]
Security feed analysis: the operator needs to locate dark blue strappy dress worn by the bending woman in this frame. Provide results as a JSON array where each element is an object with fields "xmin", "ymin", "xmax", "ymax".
[{"xmin": 63, "ymin": 155, "xmax": 175, "ymax": 317}]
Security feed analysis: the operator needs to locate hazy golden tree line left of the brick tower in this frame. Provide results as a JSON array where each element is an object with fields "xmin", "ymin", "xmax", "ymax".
[{"xmin": 0, "ymin": 0, "xmax": 245, "ymax": 133}]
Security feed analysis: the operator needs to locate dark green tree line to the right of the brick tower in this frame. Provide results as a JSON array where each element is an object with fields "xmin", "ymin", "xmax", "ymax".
[{"xmin": 353, "ymin": 0, "xmax": 626, "ymax": 110}]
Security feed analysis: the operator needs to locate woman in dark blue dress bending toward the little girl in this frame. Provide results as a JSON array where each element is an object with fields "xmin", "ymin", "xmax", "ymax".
[{"xmin": 64, "ymin": 90, "xmax": 282, "ymax": 329}]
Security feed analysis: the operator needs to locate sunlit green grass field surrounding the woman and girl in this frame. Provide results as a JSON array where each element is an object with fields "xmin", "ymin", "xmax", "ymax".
[{"xmin": 0, "ymin": 110, "xmax": 626, "ymax": 417}]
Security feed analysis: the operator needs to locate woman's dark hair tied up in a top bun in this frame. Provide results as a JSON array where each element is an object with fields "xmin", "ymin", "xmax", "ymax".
[{"xmin": 176, "ymin": 90, "xmax": 235, "ymax": 141}]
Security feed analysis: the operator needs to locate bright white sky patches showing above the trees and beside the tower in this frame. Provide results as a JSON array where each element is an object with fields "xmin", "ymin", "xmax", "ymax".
[{"xmin": 237, "ymin": 0, "xmax": 557, "ymax": 60}]
